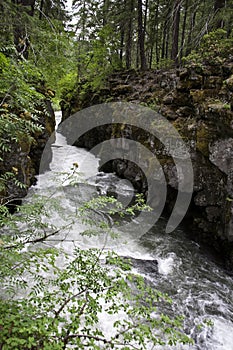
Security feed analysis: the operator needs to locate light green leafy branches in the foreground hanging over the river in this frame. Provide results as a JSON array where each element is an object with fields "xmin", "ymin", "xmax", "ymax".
[{"xmin": 0, "ymin": 189, "xmax": 195, "ymax": 350}]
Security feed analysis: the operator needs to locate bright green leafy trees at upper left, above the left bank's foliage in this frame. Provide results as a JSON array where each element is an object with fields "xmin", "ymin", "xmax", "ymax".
[{"xmin": 0, "ymin": 0, "xmax": 75, "ymax": 101}]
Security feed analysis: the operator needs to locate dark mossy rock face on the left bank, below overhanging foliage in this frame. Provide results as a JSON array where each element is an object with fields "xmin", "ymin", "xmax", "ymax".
[{"xmin": 0, "ymin": 99, "xmax": 55, "ymax": 203}]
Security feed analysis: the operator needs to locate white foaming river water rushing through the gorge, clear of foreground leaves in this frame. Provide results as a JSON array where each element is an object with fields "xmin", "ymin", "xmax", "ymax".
[{"xmin": 29, "ymin": 113, "xmax": 233, "ymax": 350}]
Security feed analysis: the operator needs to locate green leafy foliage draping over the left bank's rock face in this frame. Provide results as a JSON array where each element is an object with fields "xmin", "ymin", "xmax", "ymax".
[{"xmin": 0, "ymin": 53, "xmax": 48, "ymax": 193}]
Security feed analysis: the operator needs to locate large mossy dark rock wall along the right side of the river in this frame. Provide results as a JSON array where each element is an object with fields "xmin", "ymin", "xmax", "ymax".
[{"xmin": 63, "ymin": 62, "xmax": 233, "ymax": 269}]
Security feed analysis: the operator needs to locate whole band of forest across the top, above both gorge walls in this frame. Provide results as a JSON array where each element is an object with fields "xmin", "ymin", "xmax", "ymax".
[{"xmin": 0, "ymin": 0, "xmax": 233, "ymax": 95}]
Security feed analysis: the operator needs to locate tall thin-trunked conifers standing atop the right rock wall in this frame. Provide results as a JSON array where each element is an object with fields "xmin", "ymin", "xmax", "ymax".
[{"xmin": 72, "ymin": 0, "xmax": 233, "ymax": 69}]
